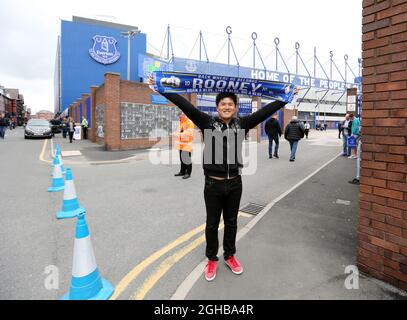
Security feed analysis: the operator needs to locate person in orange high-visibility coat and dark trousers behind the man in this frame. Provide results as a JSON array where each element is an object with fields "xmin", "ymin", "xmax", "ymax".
[{"xmin": 175, "ymin": 113, "xmax": 194, "ymax": 179}]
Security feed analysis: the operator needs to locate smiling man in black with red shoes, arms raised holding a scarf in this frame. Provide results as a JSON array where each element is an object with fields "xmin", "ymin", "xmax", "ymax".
[{"xmin": 149, "ymin": 76, "xmax": 298, "ymax": 281}]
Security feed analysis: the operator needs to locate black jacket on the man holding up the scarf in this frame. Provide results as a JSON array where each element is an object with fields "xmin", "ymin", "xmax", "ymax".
[{"xmin": 162, "ymin": 93, "xmax": 286, "ymax": 178}]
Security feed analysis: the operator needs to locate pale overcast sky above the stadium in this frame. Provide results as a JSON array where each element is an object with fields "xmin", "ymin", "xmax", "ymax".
[{"xmin": 0, "ymin": 0, "xmax": 362, "ymax": 112}]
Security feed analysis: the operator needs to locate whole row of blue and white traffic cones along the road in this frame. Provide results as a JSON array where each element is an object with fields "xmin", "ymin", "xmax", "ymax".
[{"xmin": 48, "ymin": 145, "xmax": 114, "ymax": 300}]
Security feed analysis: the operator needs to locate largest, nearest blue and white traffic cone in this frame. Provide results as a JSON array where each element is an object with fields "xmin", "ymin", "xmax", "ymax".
[{"xmin": 62, "ymin": 213, "xmax": 114, "ymax": 300}]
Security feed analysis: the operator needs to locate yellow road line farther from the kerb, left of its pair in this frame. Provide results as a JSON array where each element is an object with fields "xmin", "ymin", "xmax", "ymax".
[{"xmin": 110, "ymin": 224, "xmax": 205, "ymax": 300}]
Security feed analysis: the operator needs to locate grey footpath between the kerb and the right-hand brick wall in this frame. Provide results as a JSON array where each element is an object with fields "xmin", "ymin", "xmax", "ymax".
[{"xmin": 177, "ymin": 157, "xmax": 407, "ymax": 300}]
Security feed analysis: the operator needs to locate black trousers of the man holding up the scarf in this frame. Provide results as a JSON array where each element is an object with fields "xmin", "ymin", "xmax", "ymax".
[{"xmin": 204, "ymin": 176, "xmax": 242, "ymax": 261}]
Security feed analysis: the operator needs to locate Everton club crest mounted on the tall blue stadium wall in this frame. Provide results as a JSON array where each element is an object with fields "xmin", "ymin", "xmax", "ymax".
[{"xmin": 89, "ymin": 36, "xmax": 120, "ymax": 64}]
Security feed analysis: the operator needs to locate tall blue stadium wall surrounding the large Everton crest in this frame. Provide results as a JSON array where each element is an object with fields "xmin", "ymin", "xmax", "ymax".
[{"xmin": 60, "ymin": 21, "xmax": 146, "ymax": 112}]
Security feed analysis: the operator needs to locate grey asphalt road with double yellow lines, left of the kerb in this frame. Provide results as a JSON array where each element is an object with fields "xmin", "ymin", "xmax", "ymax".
[{"xmin": 0, "ymin": 129, "xmax": 350, "ymax": 299}]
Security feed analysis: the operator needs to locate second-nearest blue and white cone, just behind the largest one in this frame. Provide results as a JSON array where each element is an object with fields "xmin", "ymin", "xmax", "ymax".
[{"xmin": 57, "ymin": 168, "xmax": 86, "ymax": 219}]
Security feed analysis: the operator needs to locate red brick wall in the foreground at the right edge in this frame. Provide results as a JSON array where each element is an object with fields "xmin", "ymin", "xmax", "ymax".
[{"xmin": 358, "ymin": 0, "xmax": 407, "ymax": 290}]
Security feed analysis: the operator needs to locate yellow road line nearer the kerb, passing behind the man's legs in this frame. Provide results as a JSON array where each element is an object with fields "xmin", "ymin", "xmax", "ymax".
[{"xmin": 130, "ymin": 223, "xmax": 224, "ymax": 300}]
